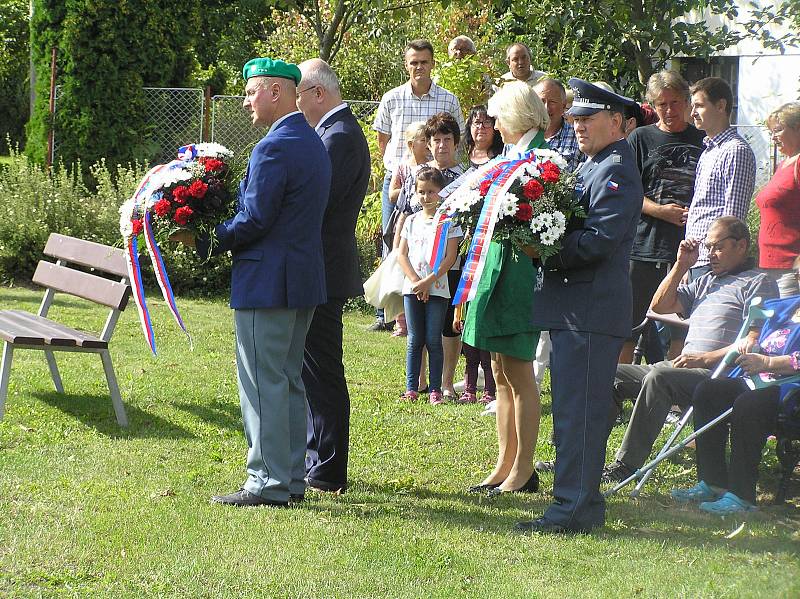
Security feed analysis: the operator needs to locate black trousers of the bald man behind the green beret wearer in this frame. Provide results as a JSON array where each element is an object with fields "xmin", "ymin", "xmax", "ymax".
[{"xmin": 303, "ymin": 298, "xmax": 350, "ymax": 488}]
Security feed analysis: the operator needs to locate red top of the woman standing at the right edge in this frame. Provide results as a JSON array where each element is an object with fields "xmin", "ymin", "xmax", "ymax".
[{"xmin": 756, "ymin": 161, "xmax": 800, "ymax": 269}]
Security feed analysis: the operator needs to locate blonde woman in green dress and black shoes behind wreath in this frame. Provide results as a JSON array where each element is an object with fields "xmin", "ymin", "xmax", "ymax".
[{"xmin": 463, "ymin": 81, "xmax": 549, "ymax": 495}]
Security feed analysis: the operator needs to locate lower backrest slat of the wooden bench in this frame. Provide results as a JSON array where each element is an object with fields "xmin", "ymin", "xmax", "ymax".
[{"xmin": 33, "ymin": 262, "xmax": 130, "ymax": 310}]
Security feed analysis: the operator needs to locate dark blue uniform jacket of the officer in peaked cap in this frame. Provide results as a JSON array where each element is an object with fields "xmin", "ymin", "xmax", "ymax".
[{"xmin": 533, "ymin": 140, "xmax": 644, "ymax": 337}]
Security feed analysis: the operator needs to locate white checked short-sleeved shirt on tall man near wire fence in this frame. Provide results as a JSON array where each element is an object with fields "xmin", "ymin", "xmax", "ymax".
[{"xmin": 372, "ymin": 82, "xmax": 464, "ymax": 172}]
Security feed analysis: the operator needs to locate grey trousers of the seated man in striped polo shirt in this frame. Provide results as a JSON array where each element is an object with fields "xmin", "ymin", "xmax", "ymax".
[{"xmin": 614, "ymin": 360, "xmax": 711, "ymax": 468}]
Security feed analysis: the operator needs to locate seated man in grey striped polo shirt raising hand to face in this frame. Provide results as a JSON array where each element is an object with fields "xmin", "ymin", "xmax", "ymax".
[{"xmin": 603, "ymin": 216, "xmax": 778, "ymax": 483}]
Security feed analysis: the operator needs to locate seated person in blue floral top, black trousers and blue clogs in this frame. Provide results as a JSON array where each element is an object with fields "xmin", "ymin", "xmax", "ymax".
[{"xmin": 672, "ymin": 257, "xmax": 800, "ymax": 515}]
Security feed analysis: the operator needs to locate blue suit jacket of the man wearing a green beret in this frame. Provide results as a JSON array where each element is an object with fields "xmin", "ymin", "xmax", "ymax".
[{"xmin": 203, "ymin": 112, "xmax": 331, "ymax": 309}]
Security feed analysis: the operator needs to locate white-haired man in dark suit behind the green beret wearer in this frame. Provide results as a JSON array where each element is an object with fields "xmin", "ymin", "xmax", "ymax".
[{"xmin": 297, "ymin": 58, "xmax": 370, "ymax": 492}]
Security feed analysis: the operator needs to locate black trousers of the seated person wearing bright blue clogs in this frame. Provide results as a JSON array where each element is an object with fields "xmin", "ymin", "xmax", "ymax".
[{"xmin": 693, "ymin": 379, "xmax": 780, "ymax": 503}]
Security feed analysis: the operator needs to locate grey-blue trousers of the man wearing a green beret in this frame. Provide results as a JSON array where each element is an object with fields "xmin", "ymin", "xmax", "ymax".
[{"xmin": 234, "ymin": 308, "xmax": 314, "ymax": 501}]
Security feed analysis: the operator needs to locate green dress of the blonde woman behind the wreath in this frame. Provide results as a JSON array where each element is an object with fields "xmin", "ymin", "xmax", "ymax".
[{"xmin": 462, "ymin": 131, "xmax": 547, "ymax": 361}]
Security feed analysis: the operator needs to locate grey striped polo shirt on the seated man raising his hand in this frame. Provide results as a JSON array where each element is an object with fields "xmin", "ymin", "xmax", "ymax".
[{"xmin": 677, "ymin": 269, "xmax": 778, "ymax": 354}]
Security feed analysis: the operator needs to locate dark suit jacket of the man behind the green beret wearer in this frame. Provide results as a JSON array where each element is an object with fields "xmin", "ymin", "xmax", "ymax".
[{"xmin": 319, "ymin": 108, "xmax": 370, "ymax": 298}]
